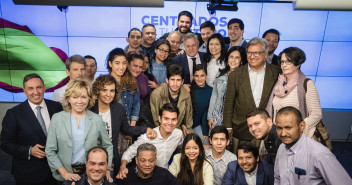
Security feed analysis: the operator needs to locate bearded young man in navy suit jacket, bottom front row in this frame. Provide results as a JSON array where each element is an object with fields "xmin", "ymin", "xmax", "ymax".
[{"xmin": 222, "ymin": 143, "xmax": 274, "ymax": 185}]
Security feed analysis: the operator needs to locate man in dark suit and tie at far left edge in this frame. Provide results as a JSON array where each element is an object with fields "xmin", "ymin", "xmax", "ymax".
[{"xmin": 1, "ymin": 74, "xmax": 62, "ymax": 185}]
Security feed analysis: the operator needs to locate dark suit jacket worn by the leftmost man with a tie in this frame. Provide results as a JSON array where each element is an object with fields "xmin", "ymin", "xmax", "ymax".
[{"xmin": 1, "ymin": 99, "xmax": 62, "ymax": 183}]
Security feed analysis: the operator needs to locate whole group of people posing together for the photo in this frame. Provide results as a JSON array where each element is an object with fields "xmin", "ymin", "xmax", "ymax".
[{"xmin": 1, "ymin": 11, "xmax": 352, "ymax": 185}]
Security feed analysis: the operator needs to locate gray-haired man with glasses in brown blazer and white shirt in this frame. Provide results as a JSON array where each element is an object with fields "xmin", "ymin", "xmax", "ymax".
[{"xmin": 223, "ymin": 37, "xmax": 280, "ymax": 151}]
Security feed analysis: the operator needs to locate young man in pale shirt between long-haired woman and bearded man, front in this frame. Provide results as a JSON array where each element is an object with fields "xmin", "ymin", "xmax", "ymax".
[{"xmin": 205, "ymin": 126, "xmax": 237, "ymax": 185}]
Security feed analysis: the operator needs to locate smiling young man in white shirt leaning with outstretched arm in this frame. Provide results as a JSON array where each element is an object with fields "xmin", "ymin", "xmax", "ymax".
[{"xmin": 116, "ymin": 103, "xmax": 183, "ymax": 179}]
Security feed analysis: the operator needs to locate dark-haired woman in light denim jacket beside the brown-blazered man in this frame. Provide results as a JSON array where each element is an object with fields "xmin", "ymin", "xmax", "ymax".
[{"xmin": 208, "ymin": 46, "xmax": 247, "ymax": 128}]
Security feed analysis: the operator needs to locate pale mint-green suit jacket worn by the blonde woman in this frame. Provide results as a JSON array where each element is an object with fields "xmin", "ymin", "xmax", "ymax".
[{"xmin": 45, "ymin": 110, "xmax": 113, "ymax": 181}]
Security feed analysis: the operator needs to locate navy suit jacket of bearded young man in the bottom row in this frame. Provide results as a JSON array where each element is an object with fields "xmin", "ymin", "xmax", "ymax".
[{"xmin": 222, "ymin": 160, "xmax": 274, "ymax": 185}]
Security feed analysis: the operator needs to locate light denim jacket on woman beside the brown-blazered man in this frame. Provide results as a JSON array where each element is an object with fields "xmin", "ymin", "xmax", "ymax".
[{"xmin": 208, "ymin": 72, "xmax": 228, "ymax": 120}]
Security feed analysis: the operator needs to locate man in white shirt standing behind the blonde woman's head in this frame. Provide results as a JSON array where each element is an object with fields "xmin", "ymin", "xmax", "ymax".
[{"xmin": 51, "ymin": 55, "xmax": 86, "ymax": 104}]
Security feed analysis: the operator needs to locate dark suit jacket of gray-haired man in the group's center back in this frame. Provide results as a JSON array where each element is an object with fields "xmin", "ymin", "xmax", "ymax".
[{"xmin": 171, "ymin": 52, "xmax": 207, "ymax": 84}]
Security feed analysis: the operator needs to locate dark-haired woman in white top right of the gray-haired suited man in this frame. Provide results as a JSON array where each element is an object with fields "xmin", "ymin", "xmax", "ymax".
[{"xmin": 205, "ymin": 33, "xmax": 227, "ymax": 87}]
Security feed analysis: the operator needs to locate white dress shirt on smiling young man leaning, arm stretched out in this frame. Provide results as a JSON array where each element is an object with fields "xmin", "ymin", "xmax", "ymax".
[{"xmin": 121, "ymin": 127, "xmax": 183, "ymax": 169}]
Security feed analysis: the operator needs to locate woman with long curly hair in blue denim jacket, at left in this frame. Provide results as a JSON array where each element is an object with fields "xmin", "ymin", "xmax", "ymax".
[{"xmin": 106, "ymin": 48, "xmax": 140, "ymax": 154}]
